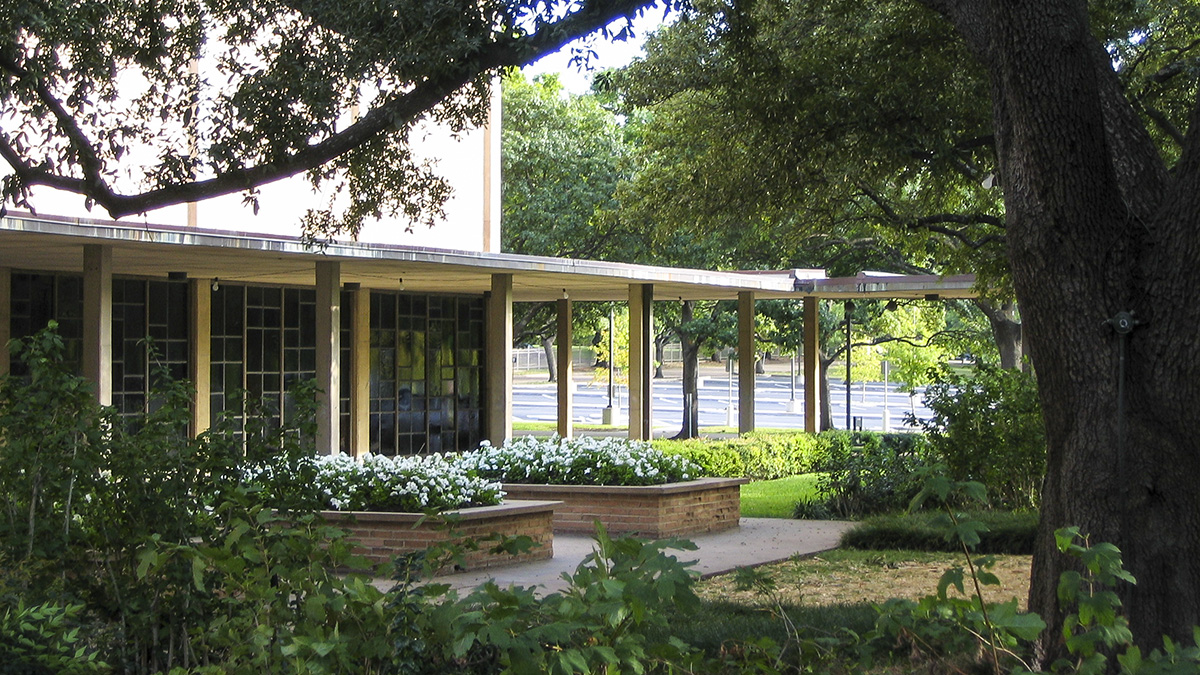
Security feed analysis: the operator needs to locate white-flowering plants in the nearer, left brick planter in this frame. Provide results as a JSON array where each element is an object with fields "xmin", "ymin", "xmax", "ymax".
[{"xmin": 250, "ymin": 454, "xmax": 504, "ymax": 513}]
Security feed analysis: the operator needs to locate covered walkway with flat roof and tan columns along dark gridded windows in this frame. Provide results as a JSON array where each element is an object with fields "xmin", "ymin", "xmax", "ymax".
[{"xmin": 0, "ymin": 214, "xmax": 973, "ymax": 455}]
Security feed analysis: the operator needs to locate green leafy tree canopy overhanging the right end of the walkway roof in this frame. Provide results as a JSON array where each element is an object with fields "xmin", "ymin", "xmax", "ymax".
[{"xmin": 608, "ymin": 0, "xmax": 1021, "ymax": 368}]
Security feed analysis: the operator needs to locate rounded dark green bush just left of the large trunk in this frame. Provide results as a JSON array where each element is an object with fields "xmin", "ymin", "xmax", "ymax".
[{"xmin": 922, "ymin": 365, "xmax": 1046, "ymax": 508}]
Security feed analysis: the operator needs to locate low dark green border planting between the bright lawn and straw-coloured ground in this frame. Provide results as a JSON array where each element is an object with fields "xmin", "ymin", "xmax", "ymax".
[{"xmin": 841, "ymin": 510, "xmax": 1038, "ymax": 555}]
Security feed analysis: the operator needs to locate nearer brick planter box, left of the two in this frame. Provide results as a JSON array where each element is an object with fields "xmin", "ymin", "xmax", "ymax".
[{"xmin": 322, "ymin": 500, "xmax": 558, "ymax": 569}]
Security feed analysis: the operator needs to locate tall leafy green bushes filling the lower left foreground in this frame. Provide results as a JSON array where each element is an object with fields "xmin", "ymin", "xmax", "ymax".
[{"xmin": 0, "ymin": 325, "xmax": 390, "ymax": 674}]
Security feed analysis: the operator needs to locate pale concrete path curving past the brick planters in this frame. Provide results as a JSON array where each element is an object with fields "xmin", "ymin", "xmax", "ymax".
[{"xmin": 438, "ymin": 518, "xmax": 854, "ymax": 592}]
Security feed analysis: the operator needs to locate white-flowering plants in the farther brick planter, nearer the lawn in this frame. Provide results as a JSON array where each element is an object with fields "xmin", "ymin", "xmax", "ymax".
[{"xmin": 458, "ymin": 436, "xmax": 701, "ymax": 485}]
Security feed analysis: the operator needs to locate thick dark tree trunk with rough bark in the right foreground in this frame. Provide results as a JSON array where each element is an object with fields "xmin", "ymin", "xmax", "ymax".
[{"xmin": 926, "ymin": 0, "xmax": 1200, "ymax": 664}]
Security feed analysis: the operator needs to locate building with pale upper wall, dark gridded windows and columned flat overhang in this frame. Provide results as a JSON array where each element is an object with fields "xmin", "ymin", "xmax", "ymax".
[{"xmin": 0, "ymin": 89, "xmax": 971, "ymax": 455}]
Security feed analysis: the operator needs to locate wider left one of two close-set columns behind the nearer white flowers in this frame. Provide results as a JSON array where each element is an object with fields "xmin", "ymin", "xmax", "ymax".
[{"xmin": 317, "ymin": 261, "xmax": 342, "ymax": 455}]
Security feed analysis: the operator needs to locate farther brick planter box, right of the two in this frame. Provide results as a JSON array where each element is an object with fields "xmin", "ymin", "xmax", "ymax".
[{"xmin": 494, "ymin": 478, "xmax": 748, "ymax": 538}]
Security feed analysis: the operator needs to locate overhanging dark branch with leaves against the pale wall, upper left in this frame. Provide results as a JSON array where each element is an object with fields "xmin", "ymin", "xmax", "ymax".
[{"xmin": 0, "ymin": 0, "xmax": 667, "ymax": 232}]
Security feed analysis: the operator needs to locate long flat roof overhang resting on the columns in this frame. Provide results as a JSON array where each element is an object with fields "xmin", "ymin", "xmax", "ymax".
[{"xmin": 0, "ymin": 214, "xmax": 973, "ymax": 301}]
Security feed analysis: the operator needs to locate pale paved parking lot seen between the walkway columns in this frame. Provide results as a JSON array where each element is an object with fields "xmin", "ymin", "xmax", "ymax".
[{"xmin": 512, "ymin": 365, "xmax": 930, "ymax": 434}]
